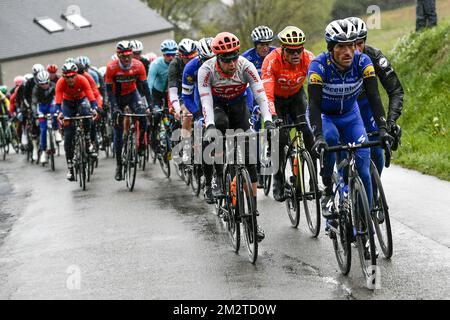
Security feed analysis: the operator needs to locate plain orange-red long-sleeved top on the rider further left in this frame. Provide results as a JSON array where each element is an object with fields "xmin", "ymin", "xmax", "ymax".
[{"xmin": 55, "ymin": 75, "xmax": 95, "ymax": 104}]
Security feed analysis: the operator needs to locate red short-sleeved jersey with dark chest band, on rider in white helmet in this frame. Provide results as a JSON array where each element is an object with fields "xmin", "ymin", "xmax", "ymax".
[{"xmin": 105, "ymin": 59, "xmax": 147, "ymax": 96}]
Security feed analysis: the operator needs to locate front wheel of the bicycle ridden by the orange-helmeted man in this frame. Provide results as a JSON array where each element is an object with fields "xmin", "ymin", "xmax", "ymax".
[{"xmin": 236, "ymin": 169, "xmax": 258, "ymax": 264}]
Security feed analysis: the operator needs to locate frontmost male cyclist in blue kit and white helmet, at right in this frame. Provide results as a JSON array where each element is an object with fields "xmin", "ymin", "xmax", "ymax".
[{"xmin": 308, "ymin": 20, "xmax": 389, "ymax": 218}]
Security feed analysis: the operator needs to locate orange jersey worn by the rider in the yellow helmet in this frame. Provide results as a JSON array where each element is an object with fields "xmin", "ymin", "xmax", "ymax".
[{"xmin": 261, "ymin": 48, "xmax": 314, "ymax": 106}]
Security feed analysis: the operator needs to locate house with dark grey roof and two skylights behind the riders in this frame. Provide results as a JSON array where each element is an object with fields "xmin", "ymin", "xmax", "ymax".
[{"xmin": 0, "ymin": 0, "xmax": 174, "ymax": 86}]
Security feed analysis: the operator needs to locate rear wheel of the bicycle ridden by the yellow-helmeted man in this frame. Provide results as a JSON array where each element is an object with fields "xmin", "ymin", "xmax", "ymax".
[{"xmin": 284, "ymin": 156, "xmax": 300, "ymax": 228}]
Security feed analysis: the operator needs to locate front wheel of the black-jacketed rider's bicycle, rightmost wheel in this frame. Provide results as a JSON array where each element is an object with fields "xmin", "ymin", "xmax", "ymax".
[{"xmin": 370, "ymin": 162, "xmax": 393, "ymax": 259}]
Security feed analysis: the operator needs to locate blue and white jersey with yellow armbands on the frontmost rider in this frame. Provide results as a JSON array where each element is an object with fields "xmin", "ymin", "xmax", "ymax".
[{"xmin": 308, "ymin": 51, "xmax": 375, "ymax": 115}]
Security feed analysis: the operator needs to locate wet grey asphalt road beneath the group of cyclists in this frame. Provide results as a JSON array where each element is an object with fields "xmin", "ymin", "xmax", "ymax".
[{"xmin": 0, "ymin": 151, "xmax": 450, "ymax": 300}]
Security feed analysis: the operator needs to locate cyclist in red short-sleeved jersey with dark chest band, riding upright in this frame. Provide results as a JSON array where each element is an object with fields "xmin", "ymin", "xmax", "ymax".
[{"xmin": 105, "ymin": 40, "xmax": 151, "ymax": 181}]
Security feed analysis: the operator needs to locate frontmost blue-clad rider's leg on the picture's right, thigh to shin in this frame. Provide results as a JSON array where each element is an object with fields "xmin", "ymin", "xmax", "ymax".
[{"xmin": 341, "ymin": 107, "xmax": 372, "ymax": 208}]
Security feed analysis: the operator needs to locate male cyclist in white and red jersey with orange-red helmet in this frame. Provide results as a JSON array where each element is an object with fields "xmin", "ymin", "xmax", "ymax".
[{"xmin": 198, "ymin": 32, "xmax": 274, "ymax": 241}]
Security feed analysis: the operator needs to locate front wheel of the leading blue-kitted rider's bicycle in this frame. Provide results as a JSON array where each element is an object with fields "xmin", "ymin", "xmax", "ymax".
[{"xmin": 351, "ymin": 177, "xmax": 377, "ymax": 285}]
